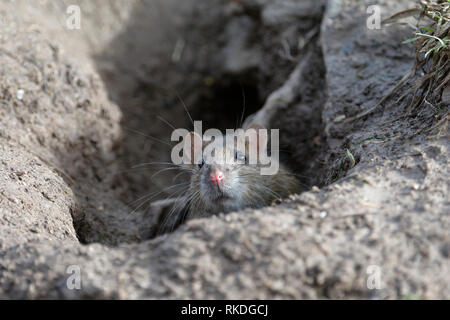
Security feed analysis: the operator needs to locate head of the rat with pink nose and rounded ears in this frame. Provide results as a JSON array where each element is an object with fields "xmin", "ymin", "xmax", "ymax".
[{"xmin": 185, "ymin": 128, "xmax": 267, "ymax": 213}]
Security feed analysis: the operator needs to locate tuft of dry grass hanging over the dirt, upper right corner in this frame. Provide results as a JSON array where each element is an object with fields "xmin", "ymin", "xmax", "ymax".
[{"xmin": 347, "ymin": 0, "xmax": 450, "ymax": 126}]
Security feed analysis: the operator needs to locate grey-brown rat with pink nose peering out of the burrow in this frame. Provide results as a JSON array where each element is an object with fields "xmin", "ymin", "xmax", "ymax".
[{"xmin": 179, "ymin": 125, "xmax": 301, "ymax": 220}]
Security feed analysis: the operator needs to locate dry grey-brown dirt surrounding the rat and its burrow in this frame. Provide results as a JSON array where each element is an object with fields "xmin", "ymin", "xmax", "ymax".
[{"xmin": 0, "ymin": 0, "xmax": 450, "ymax": 299}]
